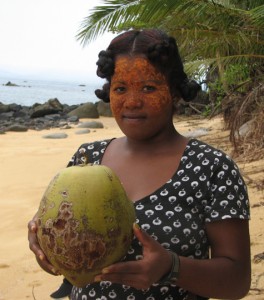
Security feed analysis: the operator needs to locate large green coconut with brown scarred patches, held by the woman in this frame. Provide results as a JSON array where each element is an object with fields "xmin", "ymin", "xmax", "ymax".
[{"xmin": 37, "ymin": 165, "xmax": 135, "ymax": 287}]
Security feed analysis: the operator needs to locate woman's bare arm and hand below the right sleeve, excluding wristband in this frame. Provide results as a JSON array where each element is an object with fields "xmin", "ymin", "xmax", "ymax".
[{"xmin": 95, "ymin": 219, "xmax": 251, "ymax": 299}]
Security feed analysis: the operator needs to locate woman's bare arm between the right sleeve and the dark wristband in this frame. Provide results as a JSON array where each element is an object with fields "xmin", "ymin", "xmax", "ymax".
[{"xmin": 178, "ymin": 219, "xmax": 251, "ymax": 299}]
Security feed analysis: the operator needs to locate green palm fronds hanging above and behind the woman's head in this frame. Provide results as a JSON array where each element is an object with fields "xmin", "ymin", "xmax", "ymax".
[{"xmin": 77, "ymin": 0, "xmax": 264, "ymax": 103}]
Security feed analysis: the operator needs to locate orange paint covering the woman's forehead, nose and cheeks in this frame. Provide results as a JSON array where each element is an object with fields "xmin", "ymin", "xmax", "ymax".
[{"xmin": 110, "ymin": 56, "xmax": 172, "ymax": 117}]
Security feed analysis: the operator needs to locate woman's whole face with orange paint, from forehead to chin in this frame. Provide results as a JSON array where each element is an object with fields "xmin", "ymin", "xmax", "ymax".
[{"xmin": 110, "ymin": 56, "xmax": 173, "ymax": 140}]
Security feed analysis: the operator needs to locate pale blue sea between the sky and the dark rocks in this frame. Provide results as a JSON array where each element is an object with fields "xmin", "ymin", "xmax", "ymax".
[{"xmin": 0, "ymin": 77, "xmax": 102, "ymax": 106}]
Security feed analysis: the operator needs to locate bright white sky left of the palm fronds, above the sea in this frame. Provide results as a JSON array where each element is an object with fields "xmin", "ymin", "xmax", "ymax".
[{"xmin": 0, "ymin": 0, "xmax": 114, "ymax": 83}]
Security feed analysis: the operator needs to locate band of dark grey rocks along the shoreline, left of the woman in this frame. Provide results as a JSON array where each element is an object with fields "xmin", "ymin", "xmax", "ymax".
[{"xmin": 0, "ymin": 98, "xmax": 112, "ymax": 134}]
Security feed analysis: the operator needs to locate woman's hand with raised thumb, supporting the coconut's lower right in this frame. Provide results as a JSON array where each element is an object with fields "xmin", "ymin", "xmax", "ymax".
[{"xmin": 95, "ymin": 224, "xmax": 172, "ymax": 289}]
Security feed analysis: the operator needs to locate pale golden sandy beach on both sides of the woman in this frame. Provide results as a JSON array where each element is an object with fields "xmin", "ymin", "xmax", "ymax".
[{"xmin": 0, "ymin": 116, "xmax": 264, "ymax": 300}]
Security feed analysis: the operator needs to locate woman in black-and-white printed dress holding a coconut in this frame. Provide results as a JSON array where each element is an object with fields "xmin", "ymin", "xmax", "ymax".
[{"xmin": 29, "ymin": 30, "xmax": 250, "ymax": 300}]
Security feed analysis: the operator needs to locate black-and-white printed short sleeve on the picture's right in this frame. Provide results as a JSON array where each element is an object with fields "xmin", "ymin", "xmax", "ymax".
[{"xmin": 205, "ymin": 155, "xmax": 250, "ymax": 222}]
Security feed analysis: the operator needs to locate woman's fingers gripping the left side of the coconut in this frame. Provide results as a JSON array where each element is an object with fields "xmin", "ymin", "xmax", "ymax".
[{"xmin": 28, "ymin": 216, "xmax": 60, "ymax": 275}]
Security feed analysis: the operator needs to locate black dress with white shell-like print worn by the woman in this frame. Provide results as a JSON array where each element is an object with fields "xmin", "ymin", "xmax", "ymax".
[{"xmin": 68, "ymin": 139, "xmax": 249, "ymax": 300}]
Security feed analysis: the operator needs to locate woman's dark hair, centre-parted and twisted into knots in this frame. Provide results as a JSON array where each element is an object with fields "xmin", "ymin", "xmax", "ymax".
[{"xmin": 95, "ymin": 29, "xmax": 200, "ymax": 102}]
